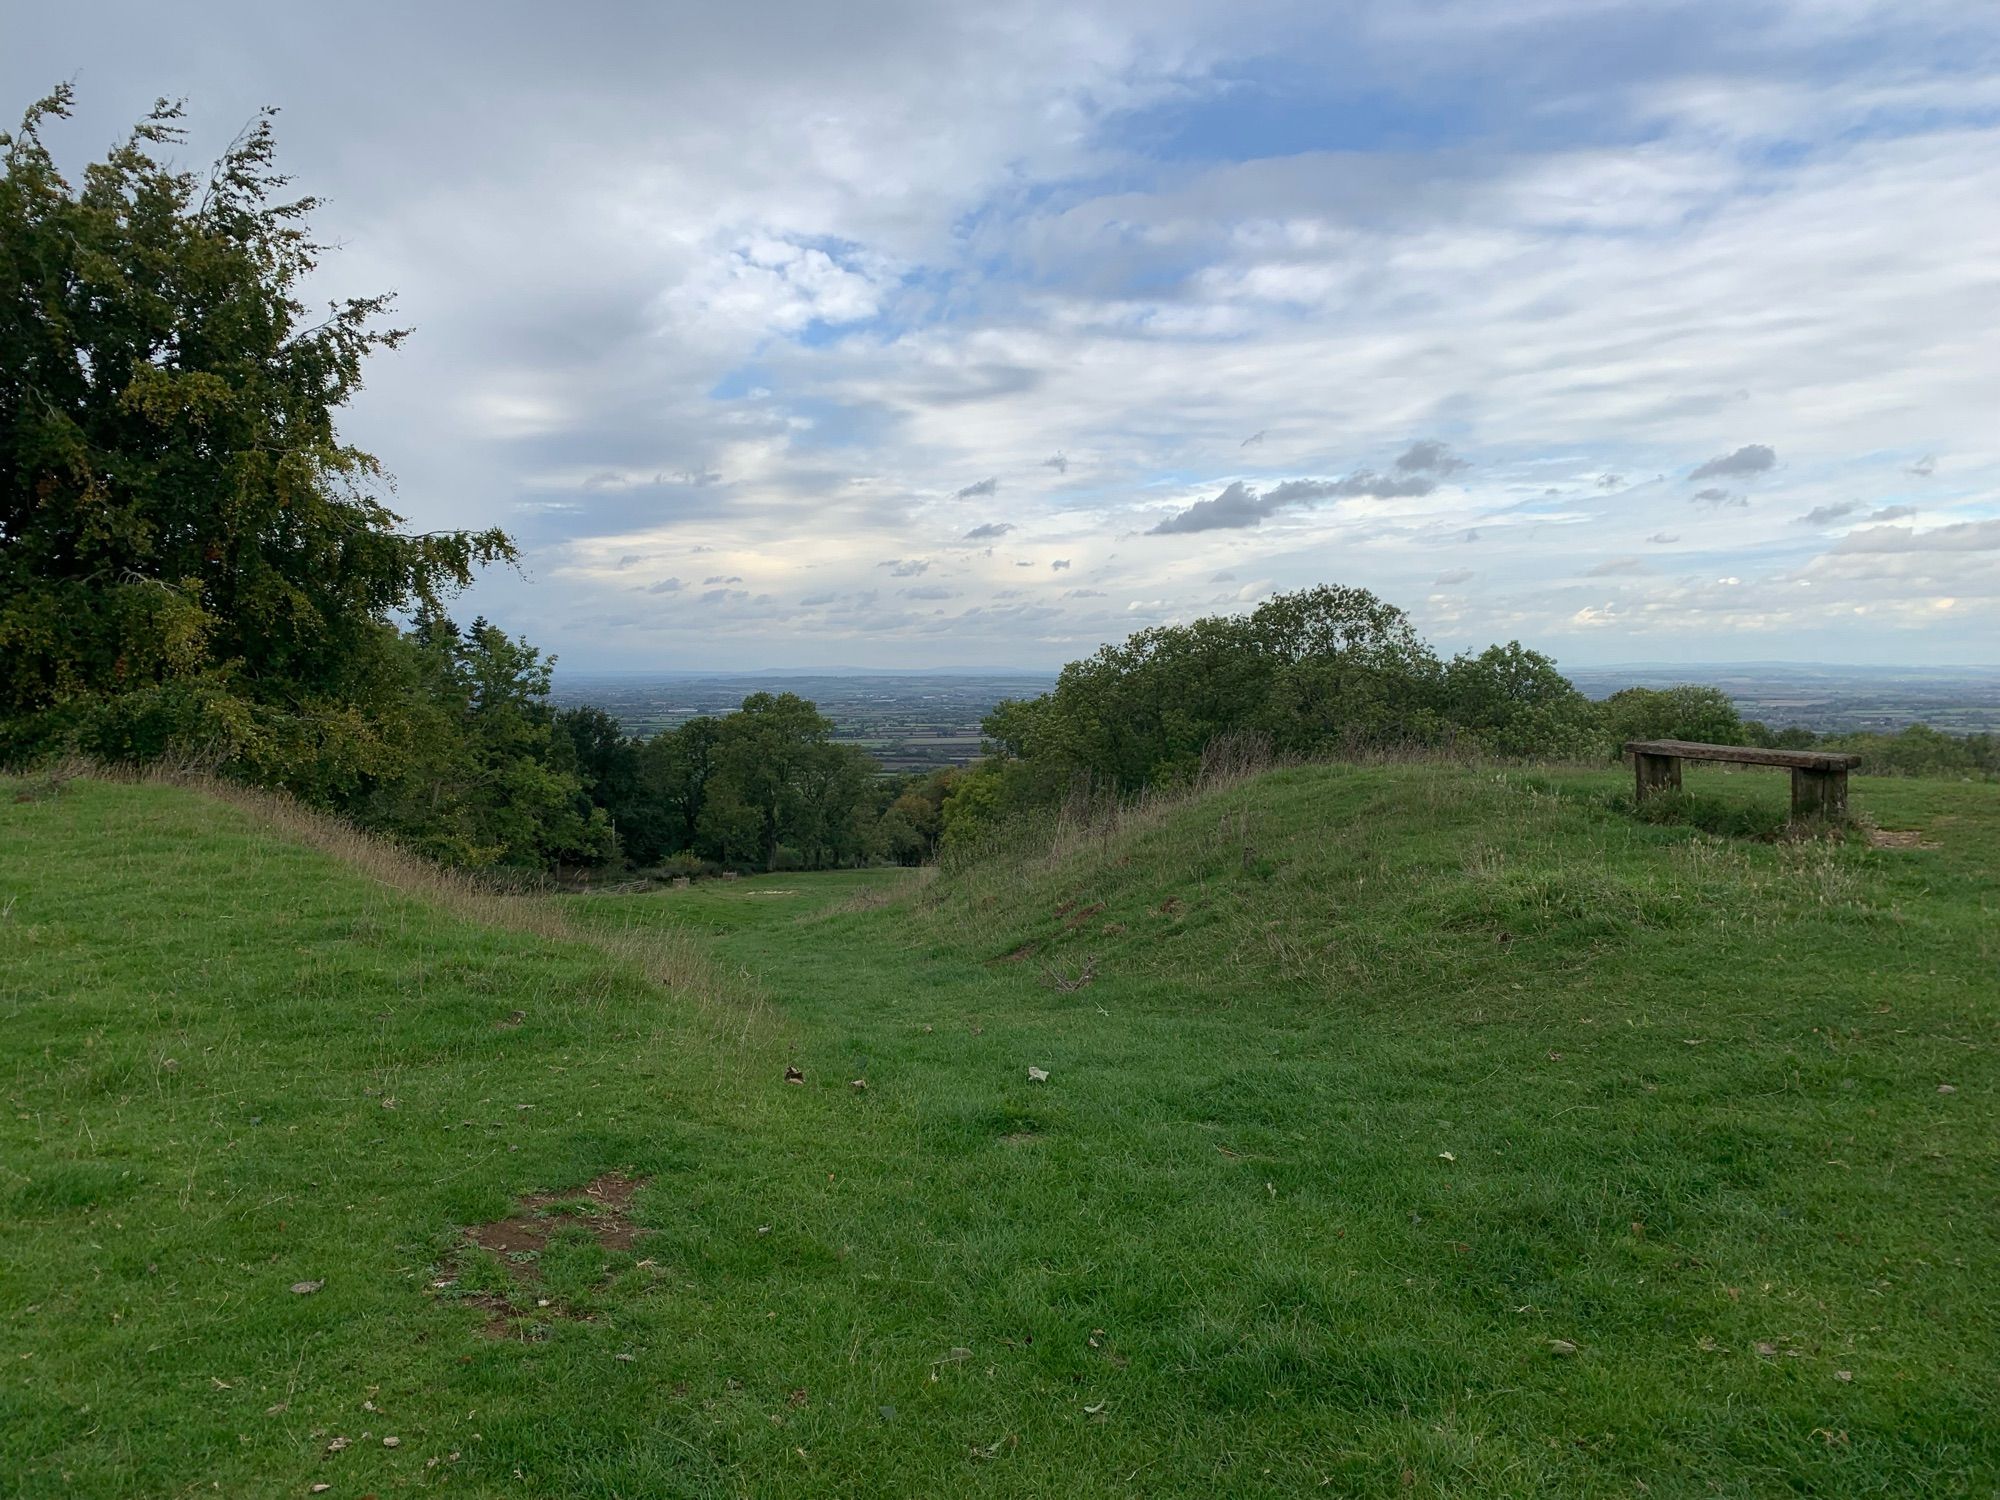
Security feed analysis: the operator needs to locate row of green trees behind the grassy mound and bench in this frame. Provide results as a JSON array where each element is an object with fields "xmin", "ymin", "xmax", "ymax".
[{"xmin": 944, "ymin": 586, "xmax": 2000, "ymax": 844}]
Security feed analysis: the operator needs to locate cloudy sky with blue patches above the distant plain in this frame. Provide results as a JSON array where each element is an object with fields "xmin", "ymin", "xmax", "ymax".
[{"xmin": 15, "ymin": 0, "xmax": 2000, "ymax": 668}]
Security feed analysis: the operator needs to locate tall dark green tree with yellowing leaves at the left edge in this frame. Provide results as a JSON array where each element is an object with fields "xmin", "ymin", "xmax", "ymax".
[{"xmin": 0, "ymin": 88, "xmax": 514, "ymax": 796}]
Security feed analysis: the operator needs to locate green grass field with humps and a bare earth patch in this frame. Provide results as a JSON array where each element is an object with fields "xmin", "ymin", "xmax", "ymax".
[{"xmin": 0, "ymin": 766, "xmax": 2000, "ymax": 1500}]
